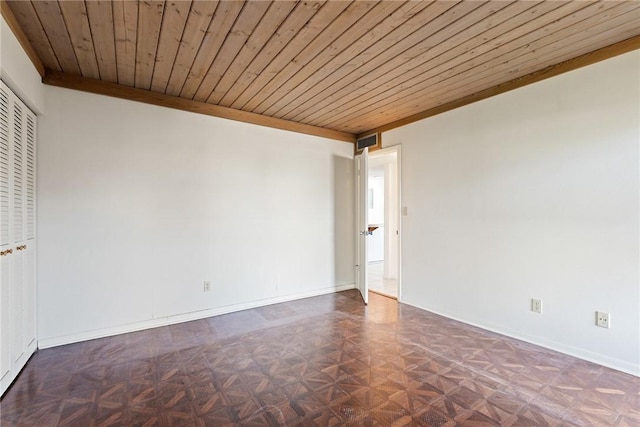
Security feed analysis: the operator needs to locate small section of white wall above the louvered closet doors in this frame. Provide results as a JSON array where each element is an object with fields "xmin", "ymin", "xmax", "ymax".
[{"xmin": 0, "ymin": 16, "xmax": 44, "ymax": 113}]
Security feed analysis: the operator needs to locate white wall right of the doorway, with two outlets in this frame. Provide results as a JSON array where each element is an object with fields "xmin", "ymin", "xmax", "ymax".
[{"xmin": 383, "ymin": 51, "xmax": 640, "ymax": 375}]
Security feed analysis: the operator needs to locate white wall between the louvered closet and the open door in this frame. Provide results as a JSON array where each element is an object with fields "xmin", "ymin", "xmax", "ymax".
[{"xmin": 38, "ymin": 87, "xmax": 354, "ymax": 347}]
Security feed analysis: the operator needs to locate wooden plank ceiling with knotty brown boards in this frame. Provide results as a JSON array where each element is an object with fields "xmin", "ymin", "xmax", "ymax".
[{"xmin": 8, "ymin": 0, "xmax": 640, "ymax": 140}]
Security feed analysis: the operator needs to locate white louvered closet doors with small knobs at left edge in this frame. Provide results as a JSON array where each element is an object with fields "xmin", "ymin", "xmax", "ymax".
[{"xmin": 0, "ymin": 82, "xmax": 37, "ymax": 393}]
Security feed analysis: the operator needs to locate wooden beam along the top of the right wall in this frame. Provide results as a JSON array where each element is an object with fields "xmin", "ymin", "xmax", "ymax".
[{"xmin": 358, "ymin": 36, "xmax": 640, "ymax": 137}]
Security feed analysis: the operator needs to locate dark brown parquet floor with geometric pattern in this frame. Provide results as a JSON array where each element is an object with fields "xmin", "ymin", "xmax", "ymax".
[{"xmin": 0, "ymin": 291, "xmax": 640, "ymax": 427}]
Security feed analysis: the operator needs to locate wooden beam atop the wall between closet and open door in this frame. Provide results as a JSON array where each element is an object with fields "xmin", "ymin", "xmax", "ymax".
[{"xmin": 43, "ymin": 71, "xmax": 355, "ymax": 143}]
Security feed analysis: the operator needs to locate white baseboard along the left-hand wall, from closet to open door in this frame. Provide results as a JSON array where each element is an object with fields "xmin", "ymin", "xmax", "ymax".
[{"xmin": 38, "ymin": 283, "xmax": 356, "ymax": 349}]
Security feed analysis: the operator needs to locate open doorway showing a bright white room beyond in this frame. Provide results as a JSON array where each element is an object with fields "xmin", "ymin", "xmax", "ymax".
[{"xmin": 366, "ymin": 147, "xmax": 400, "ymax": 299}]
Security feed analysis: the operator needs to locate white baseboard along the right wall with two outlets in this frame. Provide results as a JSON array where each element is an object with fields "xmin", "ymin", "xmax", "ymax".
[{"xmin": 402, "ymin": 301, "xmax": 640, "ymax": 377}]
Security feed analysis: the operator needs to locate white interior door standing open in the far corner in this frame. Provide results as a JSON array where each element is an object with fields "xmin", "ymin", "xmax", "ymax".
[{"xmin": 355, "ymin": 148, "xmax": 369, "ymax": 304}]
